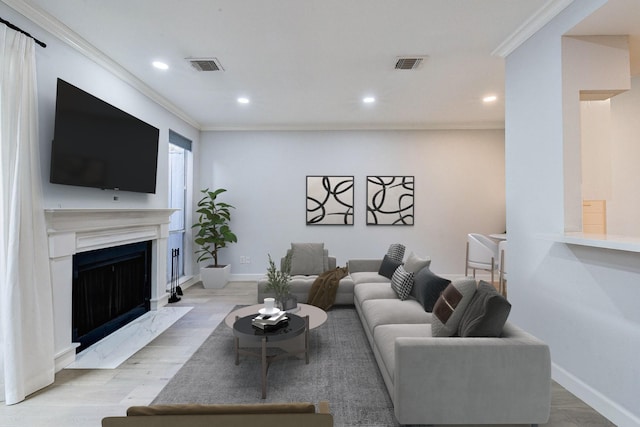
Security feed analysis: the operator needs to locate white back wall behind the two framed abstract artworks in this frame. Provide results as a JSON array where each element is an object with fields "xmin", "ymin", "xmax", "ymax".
[{"xmin": 199, "ymin": 130, "xmax": 505, "ymax": 277}]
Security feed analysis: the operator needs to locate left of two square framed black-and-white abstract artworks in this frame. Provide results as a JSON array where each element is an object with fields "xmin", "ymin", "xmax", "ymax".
[{"xmin": 307, "ymin": 176, "xmax": 353, "ymax": 225}]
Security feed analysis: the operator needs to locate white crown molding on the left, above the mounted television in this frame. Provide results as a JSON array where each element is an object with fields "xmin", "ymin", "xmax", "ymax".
[{"xmin": 2, "ymin": 0, "xmax": 200, "ymax": 130}]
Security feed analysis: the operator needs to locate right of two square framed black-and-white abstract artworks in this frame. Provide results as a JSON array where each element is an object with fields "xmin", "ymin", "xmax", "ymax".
[{"xmin": 367, "ymin": 176, "xmax": 415, "ymax": 225}]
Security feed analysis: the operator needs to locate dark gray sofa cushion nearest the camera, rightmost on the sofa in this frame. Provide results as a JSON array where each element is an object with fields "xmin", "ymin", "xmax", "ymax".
[{"xmin": 458, "ymin": 280, "xmax": 511, "ymax": 337}]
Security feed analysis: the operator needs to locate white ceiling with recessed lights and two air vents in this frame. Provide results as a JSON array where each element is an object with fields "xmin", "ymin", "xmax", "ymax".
[{"xmin": 4, "ymin": 0, "xmax": 640, "ymax": 129}]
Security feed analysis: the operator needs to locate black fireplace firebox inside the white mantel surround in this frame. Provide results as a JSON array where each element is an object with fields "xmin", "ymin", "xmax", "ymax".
[{"xmin": 71, "ymin": 241, "xmax": 151, "ymax": 353}]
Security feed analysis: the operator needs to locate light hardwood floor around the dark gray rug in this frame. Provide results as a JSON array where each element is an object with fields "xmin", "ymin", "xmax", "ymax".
[{"xmin": 0, "ymin": 282, "xmax": 613, "ymax": 427}]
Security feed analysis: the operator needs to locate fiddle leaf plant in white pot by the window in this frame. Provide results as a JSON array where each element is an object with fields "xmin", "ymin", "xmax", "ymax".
[{"xmin": 192, "ymin": 188, "xmax": 238, "ymax": 288}]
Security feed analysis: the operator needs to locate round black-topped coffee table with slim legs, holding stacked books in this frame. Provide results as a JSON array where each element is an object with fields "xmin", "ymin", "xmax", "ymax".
[{"xmin": 233, "ymin": 313, "xmax": 309, "ymax": 399}]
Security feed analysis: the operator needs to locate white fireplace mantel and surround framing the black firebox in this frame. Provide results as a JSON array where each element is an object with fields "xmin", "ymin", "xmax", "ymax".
[{"xmin": 45, "ymin": 209, "xmax": 174, "ymax": 371}]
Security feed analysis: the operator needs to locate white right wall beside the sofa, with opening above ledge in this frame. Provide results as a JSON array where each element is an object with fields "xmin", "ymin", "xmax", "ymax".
[{"xmin": 505, "ymin": 0, "xmax": 640, "ymax": 426}]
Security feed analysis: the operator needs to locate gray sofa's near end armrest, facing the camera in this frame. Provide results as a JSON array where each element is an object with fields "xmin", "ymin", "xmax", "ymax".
[{"xmin": 393, "ymin": 325, "xmax": 551, "ymax": 424}]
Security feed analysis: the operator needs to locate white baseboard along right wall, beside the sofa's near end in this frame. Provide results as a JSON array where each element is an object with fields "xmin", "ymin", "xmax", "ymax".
[{"xmin": 551, "ymin": 363, "xmax": 640, "ymax": 427}]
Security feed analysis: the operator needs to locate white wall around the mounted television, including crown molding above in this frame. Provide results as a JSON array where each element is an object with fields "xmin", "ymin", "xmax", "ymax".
[{"xmin": 0, "ymin": 3, "xmax": 199, "ymax": 209}]
